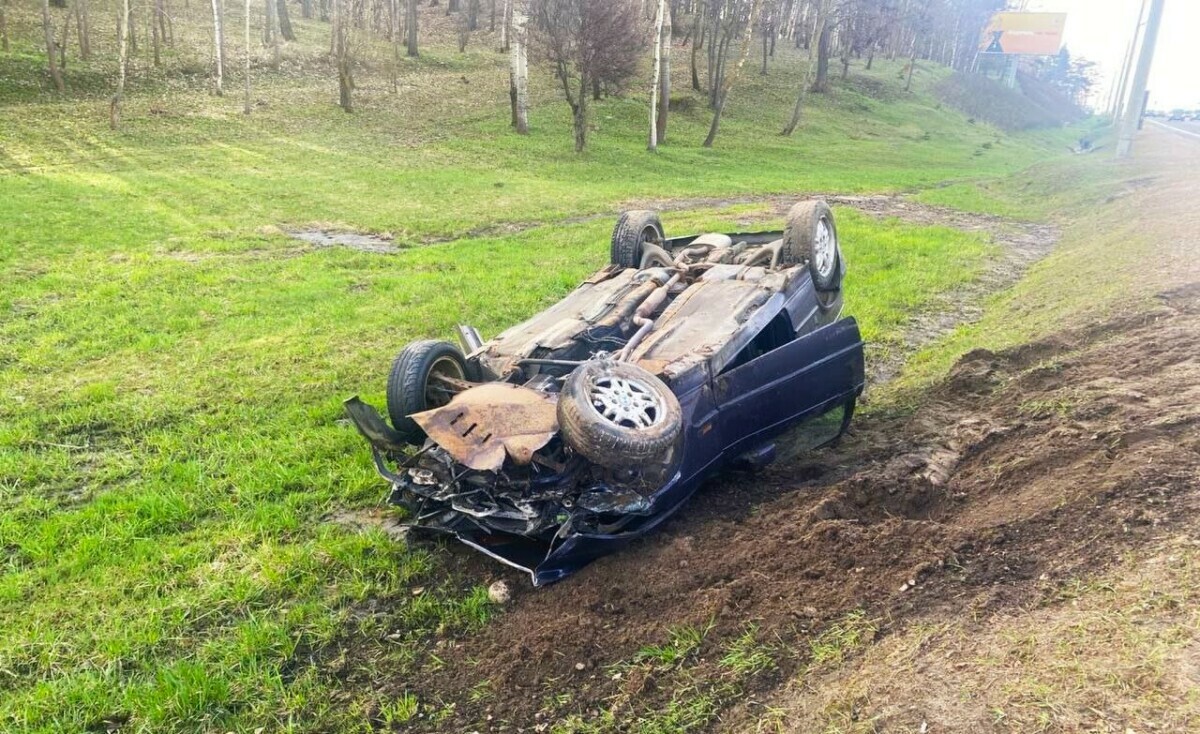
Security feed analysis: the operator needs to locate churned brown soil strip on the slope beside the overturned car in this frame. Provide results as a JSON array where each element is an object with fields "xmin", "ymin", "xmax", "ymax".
[{"xmin": 357, "ymin": 288, "xmax": 1200, "ymax": 730}]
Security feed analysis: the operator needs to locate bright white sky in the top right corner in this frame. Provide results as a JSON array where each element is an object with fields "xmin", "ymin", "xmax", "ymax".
[{"xmin": 1013, "ymin": 0, "xmax": 1200, "ymax": 110}]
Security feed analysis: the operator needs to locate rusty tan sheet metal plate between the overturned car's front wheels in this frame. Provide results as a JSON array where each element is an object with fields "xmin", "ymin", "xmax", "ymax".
[{"xmin": 410, "ymin": 383, "xmax": 558, "ymax": 471}]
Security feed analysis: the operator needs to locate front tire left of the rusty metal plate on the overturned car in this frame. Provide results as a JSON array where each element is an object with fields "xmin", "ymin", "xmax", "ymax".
[{"xmin": 388, "ymin": 339, "xmax": 467, "ymax": 445}]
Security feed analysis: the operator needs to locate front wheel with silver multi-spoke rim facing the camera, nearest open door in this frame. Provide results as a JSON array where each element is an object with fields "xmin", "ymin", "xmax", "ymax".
[{"xmin": 558, "ymin": 360, "xmax": 683, "ymax": 469}]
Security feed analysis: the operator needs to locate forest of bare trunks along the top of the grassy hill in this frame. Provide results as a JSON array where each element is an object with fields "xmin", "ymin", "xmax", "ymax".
[{"xmin": 0, "ymin": 0, "xmax": 1093, "ymax": 151}]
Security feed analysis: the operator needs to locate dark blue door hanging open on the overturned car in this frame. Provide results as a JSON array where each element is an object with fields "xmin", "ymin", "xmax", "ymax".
[{"xmin": 714, "ymin": 318, "xmax": 864, "ymax": 453}]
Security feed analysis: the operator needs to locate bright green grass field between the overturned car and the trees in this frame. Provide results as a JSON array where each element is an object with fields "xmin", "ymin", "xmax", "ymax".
[{"xmin": 0, "ymin": 7, "xmax": 1089, "ymax": 732}]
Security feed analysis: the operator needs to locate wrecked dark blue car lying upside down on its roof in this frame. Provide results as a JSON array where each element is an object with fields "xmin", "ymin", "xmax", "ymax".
[{"xmin": 346, "ymin": 200, "xmax": 864, "ymax": 585}]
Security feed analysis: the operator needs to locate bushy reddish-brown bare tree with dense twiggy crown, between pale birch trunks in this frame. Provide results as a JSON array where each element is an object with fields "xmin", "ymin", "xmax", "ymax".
[{"xmin": 534, "ymin": 0, "xmax": 644, "ymax": 152}]
